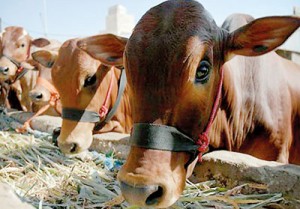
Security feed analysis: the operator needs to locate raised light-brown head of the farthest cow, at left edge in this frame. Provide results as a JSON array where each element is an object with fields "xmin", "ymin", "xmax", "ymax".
[{"xmin": 0, "ymin": 26, "xmax": 48, "ymax": 80}]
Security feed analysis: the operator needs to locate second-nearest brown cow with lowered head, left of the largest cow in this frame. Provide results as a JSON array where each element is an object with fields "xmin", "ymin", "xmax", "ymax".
[{"xmin": 36, "ymin": 34, "xmax": 132, "ymax": 155}]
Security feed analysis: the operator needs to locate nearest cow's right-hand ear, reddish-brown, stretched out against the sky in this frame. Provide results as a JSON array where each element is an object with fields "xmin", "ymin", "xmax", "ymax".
[{"xmin": 226, "ymin": 16, "xmax": 300, "ymax": 56}]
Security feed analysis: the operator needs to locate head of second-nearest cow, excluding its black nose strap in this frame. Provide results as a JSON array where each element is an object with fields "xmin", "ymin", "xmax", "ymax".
[{"xmin": 35, "ymin": 34, "xmax": 127, "ymax": 155}]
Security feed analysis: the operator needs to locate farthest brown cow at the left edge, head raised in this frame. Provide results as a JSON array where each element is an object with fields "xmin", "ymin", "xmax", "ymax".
[{"xmin": 0, "ymin": 26, "xmax": 48, "ymax": 111}]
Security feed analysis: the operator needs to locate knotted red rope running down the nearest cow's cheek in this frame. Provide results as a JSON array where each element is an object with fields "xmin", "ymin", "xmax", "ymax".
[{"xmin": 196, "ymin": 67, "xmax": 224, "ymax": 162}]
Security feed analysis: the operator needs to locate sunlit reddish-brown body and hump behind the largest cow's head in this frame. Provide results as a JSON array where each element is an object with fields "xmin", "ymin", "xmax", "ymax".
[{"xmin": 210, "ymin": 14, "xmax": 300, "ymax": 164}]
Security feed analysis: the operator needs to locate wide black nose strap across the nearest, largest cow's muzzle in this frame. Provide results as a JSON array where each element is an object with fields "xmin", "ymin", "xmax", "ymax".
[{"xmin": 130, "ymin": 123, "xmax": 199, "ymax": 155}]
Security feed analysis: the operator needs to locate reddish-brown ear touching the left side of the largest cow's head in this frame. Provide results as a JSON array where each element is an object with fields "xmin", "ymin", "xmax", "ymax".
[{"xmin": 78, "ymin": 34, "xmax": 128, "ymax": 66}]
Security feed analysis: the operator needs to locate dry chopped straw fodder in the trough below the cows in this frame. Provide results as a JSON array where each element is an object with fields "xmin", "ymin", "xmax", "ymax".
[{"xmin": 0, "ymin": 131, "xmax": 296, "ymax": 209}]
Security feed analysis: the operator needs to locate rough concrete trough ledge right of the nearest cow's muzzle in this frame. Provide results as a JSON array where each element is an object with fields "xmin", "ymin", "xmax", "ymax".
[{"xmin": 191, "ymin": 151, "xmax": 300, "ymax": 199}]
